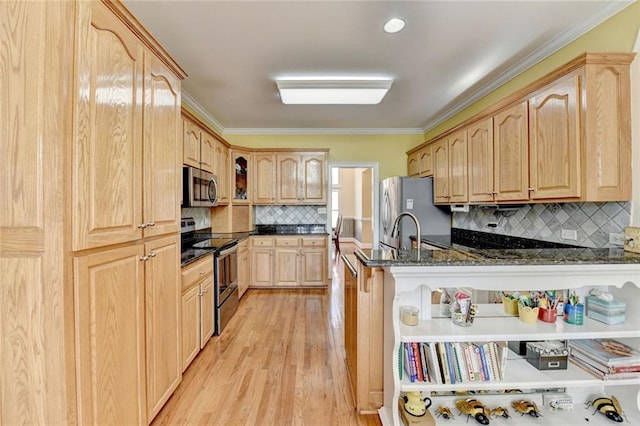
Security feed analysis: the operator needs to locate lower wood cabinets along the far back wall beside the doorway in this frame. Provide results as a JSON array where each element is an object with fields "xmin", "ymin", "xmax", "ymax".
[{"xmin": 251, "ymin": 235, "xmax": 328, "ymax": 287}]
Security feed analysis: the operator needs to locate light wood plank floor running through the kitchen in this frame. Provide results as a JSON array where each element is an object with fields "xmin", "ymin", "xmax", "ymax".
[{"xmin": 153, "ymin": 247, "xmax": 380, "ymax": 426}]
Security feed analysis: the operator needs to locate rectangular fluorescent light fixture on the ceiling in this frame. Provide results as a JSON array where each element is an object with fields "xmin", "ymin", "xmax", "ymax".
[{"xmin": 276, "ymin": 78, "xmax": 393, "ymax": 105}]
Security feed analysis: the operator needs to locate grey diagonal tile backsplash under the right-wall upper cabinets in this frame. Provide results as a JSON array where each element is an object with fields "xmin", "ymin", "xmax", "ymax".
[{"xmin": 453, "ymin": 202, "xmax": 631, "ymax": 248}]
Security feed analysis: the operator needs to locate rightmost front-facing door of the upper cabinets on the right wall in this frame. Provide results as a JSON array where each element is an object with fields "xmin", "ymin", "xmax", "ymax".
[{"xmin": 529, "ymin": 74, "xmax": 580, "ymax": 199}]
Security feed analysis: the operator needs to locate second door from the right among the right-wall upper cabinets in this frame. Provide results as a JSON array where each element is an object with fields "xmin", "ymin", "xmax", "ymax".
[{"xmin": 493, "ymin": 101, "xmax": 529, "ymax": 201}]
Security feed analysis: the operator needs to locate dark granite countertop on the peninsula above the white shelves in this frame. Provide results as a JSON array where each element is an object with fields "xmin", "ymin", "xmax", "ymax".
[{"xmin": 355, "ymin": 245, "xmax": 640, "ymax": 266}]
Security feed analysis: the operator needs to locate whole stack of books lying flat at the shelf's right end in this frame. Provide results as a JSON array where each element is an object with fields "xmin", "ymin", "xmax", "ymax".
[{"xmin": 569, "ymin": 339, "xmax": 640, "ymax": 380}]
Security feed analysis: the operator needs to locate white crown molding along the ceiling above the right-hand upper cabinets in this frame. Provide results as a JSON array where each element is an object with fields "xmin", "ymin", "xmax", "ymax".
[{"xmin": 422, "ymin": 0, "xmax": 636, "ymax": 133}]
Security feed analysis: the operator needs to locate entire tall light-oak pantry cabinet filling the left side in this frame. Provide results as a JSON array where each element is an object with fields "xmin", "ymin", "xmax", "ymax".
[{"xmin": 0, "ymin": 1, "xmax": 186, "ymax": 424}]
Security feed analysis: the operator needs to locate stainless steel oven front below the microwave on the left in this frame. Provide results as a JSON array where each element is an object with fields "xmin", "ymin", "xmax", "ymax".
[{"xmin": 214, "ymin": 241, "xmax": 240, "ymax": 334}]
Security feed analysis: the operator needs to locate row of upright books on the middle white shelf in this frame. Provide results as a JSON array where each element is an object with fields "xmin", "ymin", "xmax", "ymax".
[{"xmin": 400, "ymin": 342, "xmax": 509, "ymax": 384}]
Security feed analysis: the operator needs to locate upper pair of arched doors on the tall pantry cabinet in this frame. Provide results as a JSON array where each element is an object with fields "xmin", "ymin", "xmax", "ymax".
[{"xmin": 72, "ymin": 3, "xmax": 181, "ymax": 250}]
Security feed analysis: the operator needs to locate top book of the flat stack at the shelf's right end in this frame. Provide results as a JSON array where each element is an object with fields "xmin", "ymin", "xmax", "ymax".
[{"xmin": 569, "ymin": 338, "xmax": 640, "ymax": 366}]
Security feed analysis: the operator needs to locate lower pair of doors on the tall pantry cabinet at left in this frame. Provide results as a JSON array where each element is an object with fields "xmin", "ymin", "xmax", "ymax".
[{"xmin": 74, "ymin": 235, "xmax": 182, "ymax": 424}]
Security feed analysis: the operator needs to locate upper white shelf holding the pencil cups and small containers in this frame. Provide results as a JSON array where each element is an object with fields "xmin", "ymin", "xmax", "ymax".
[{"xmin": 400, "ymin": 303, "xmax": 640, "ymax": 342}]
